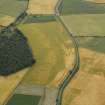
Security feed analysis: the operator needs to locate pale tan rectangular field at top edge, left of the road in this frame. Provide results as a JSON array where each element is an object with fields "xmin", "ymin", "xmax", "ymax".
[{"xmin": 27, "ymin": 0, "xmax": 58, "ymax": 14}]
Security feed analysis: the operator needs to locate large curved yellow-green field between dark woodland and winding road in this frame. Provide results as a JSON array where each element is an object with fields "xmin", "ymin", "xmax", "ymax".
[{"xmin": 19, "ymin": 21, "xmax": 74, "ymax": 86}]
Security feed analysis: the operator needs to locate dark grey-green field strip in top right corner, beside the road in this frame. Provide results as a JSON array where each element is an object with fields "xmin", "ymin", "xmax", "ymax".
[{"xmin": 59, "ymin": 0, "xmax": 105, "ymax": 15}]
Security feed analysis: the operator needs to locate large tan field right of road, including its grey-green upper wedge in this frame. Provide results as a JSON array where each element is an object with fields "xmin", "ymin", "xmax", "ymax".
[{"xmin": 62, "ymin": 37, "xmax": 105, "ymax": 105}]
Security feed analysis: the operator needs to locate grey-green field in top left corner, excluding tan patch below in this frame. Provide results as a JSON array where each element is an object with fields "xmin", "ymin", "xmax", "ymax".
[{"xmin": 0, "ymin": 0, "xmax": 28, "ymax": 17}]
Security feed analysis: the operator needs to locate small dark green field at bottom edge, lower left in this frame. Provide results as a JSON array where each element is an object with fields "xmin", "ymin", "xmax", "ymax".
[{"xmin": 6, "ymin": 94, "xmax": 40, "ymax": 105}]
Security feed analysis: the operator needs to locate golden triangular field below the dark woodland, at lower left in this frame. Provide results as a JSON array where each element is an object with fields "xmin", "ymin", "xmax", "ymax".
[{"xmin": 0, "ymin": 68, "xmax": 29, "ymax": 105}]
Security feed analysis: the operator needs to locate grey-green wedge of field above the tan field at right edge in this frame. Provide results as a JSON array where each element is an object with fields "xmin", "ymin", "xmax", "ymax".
[{"xmin": 77, "ymin": 37, "xmax": 105, "ymax": 53}]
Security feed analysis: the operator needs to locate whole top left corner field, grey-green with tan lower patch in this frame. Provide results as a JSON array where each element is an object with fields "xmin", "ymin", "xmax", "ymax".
[{"xmin": 0, "ymin": 0, "xmax": 28, "ymax": 26}]
